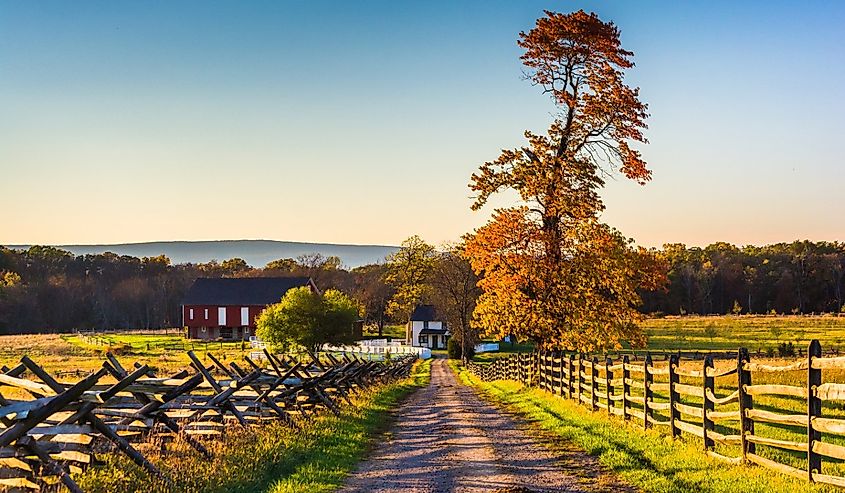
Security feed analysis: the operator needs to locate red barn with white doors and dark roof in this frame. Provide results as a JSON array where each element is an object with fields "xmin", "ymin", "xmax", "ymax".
[{"xmin": 182, "ymin": 277, "xmax": 317, "ymax": 340}]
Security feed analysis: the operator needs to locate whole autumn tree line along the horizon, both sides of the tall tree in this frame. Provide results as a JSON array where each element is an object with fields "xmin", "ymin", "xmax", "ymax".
[{"xmin": 0, "ymin": 237, "xmax": 845, "ymax": 339}]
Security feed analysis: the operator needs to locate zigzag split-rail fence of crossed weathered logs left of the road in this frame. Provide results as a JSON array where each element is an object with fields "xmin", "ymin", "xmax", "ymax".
[{"xmin": 0, "ymin": 350, "xmax": 415, "ymax": 492}]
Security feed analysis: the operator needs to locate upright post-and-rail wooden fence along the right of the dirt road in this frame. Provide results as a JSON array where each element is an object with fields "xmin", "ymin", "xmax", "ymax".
[{"xmin": 468, "ymin": 340, "xmax": 845, "ymax": 487}]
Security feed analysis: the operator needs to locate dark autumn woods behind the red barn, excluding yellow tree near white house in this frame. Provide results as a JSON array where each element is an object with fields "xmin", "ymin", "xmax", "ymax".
[{"xmin": 0, "ymin": 246, "xmax": 382, "ymax": 334}]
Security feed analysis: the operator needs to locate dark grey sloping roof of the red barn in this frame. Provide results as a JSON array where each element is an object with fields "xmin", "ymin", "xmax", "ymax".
[{"xmin": 182, "ymin": 277, "xmax": 313, "ymax": 305}]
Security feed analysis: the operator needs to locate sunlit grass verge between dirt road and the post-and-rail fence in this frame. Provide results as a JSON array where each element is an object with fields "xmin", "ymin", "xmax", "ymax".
[{"xmin": 452, "ymin": 364, "xmax": 840, "ymax": 493}]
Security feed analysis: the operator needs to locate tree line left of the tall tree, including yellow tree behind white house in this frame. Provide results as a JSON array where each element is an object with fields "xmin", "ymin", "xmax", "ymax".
[{"xmin": 0, "ymin": 241, "xmax": 477, "ymax": 335}]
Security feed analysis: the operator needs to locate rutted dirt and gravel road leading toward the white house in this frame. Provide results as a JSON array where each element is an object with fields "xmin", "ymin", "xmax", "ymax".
[{"xmin": 340, "ymin": 359, "xmax": 632, "ymax": 493}]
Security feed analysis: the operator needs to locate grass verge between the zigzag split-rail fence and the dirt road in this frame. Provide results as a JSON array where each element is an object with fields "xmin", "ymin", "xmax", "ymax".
[{"xmin": 73, "ymin": 360, "xmax": 431, "ymax": 493}]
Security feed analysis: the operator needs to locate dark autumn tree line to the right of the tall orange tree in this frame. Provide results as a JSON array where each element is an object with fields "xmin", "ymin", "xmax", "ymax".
[{"xmin": 641, "ymin": 241, "xmax": 845, "ymax": 315}]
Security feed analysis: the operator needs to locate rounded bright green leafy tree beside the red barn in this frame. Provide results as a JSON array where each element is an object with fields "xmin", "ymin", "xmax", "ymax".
[{"xmin": 256, "ymin": 287, "xmax": 358, "ymax": 351}]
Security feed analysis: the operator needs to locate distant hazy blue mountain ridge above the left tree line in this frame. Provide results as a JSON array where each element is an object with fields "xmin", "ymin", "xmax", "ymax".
[{"xmin": 6, "ymin": 240, "xmax": 399, "ymax": 268}]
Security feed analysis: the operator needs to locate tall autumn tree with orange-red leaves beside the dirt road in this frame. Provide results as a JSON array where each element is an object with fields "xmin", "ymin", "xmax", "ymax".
[{"xmin": 465, "ymin": 11, "xmax": 662, "ymax": 350}]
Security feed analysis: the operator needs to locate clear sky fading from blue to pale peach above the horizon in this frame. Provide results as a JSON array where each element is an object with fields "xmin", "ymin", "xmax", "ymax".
[{"xmin": 0, "ymin": 0, "xmax": 845, "ymax": 246}]
